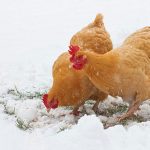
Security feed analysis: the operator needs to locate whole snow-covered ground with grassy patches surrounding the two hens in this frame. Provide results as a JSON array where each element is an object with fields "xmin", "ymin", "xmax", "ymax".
[{"xmin": 0, "ymin": 0, "xmax": 150, "ymax": 150}]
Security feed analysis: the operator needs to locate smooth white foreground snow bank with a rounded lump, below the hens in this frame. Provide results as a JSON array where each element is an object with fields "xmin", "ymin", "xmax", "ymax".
[{"xmin": 0, "ymin": 115, "xmax": 150, "ymax": 150}]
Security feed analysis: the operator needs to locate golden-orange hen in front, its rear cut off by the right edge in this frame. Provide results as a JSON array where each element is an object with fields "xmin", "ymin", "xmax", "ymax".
[{"xmin": 72, "ymin": 27, "xmax": 150, "ymax": 121}]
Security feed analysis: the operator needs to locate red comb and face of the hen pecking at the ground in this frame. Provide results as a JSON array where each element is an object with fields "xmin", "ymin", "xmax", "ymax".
[{"xmin": 42, "ymin": 94, "xmax": 59, "ymax": 112}]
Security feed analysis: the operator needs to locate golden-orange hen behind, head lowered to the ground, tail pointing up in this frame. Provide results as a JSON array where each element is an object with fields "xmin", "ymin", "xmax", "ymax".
[{"xmin": 43, "ymin": 14, "xmax": 112, "ymax": 115}]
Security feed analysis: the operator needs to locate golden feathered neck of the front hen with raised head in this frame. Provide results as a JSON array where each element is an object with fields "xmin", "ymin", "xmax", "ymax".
[{"xmin": 84, "ymin": 52, "xmax": 119, "ymax": 91}]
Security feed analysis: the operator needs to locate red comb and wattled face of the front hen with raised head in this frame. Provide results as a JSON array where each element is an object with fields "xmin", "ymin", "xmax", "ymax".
[{"xmin": 69, "ymin": 45, "xmax": 87, "ymax": 70}]
